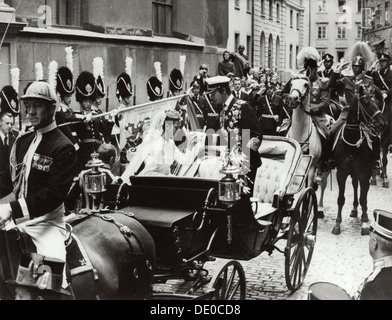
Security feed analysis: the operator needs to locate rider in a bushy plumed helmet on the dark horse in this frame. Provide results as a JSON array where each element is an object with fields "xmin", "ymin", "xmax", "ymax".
[{"xmin": 329, "ymin": 42, "xmax": 384, "ymax": 174}]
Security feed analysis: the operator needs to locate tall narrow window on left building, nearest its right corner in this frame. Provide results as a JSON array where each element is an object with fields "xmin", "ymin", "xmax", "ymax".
[{"xmin": 152, "ymin": 0, "xmax": 173, "ymax": 35}]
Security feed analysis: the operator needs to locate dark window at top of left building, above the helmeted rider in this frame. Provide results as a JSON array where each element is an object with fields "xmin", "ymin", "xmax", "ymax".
[{"xmin": 52, "ymin": 0, "xmax": 84, "ymax": 27}]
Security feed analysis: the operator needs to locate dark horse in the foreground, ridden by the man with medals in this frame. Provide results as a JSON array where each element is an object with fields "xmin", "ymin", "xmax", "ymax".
[{"xmin": 0, "ymin": 211, "xmax": 155, "ymax": 300}]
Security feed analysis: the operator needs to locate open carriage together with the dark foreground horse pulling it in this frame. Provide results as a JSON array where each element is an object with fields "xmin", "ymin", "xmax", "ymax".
[{"xmin": 0, "ymin": 90, "xmax": 317, "ymax": 299}]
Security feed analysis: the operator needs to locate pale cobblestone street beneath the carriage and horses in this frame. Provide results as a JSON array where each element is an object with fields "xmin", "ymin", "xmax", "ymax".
[{"xmin": 154, "ymin": 155, "xmax": 392, "ymax": 300}]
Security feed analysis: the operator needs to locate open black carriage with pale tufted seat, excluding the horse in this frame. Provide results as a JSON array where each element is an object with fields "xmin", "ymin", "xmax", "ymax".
[{"xmin": 60, "ymin": 136, "xmax": 317, "ymax": 300}]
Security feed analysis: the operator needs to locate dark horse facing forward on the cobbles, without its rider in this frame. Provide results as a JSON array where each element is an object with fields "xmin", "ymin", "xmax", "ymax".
[{"xmin": 332, "ymin": 85, "xmax": 385, "ymax": 235}]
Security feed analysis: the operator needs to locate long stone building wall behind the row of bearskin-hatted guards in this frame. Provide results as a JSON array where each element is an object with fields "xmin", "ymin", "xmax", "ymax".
[{"xmin": 0, "ymin": 0, "xmax": 229, "ymax": 114}]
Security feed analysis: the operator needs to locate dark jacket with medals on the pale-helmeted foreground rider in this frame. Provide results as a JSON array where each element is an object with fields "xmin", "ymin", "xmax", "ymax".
[{"xmin": 10, "ymin": 123, "xmax": 77, "ymax": 219}]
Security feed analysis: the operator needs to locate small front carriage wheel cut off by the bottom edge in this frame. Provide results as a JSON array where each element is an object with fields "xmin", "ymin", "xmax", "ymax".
[{"xmin": 211, "ymin": 260, "xmax": 246, "ymax": 300}]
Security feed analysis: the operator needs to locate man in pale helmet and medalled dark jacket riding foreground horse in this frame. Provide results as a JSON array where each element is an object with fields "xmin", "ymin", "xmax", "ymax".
[{"xmin": 0, "ymin": 81, "xmax": 77, "ymax": 298}]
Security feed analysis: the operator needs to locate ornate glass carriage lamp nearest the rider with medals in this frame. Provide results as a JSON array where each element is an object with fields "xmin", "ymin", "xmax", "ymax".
[{"xmin": 84, "ymin": 152, "xmax": 106, "ymax": 197}]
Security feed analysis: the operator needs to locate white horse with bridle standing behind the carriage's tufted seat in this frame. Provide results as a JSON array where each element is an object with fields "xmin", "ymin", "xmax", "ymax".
[{"xmin": 287, "ymin": 74, "xmax": 322, "ymax": 189}]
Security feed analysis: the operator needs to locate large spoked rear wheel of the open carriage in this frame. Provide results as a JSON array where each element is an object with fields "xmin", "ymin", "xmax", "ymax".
[{"xmin": 285, "ymin": 188, "xmax": 317, "ymax": 291}]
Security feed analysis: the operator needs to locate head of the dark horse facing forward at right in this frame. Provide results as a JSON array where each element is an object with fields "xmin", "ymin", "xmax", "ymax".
[{"xmin": 354, "ymin": 84, "xmax": 386, "ymax": 133}]
